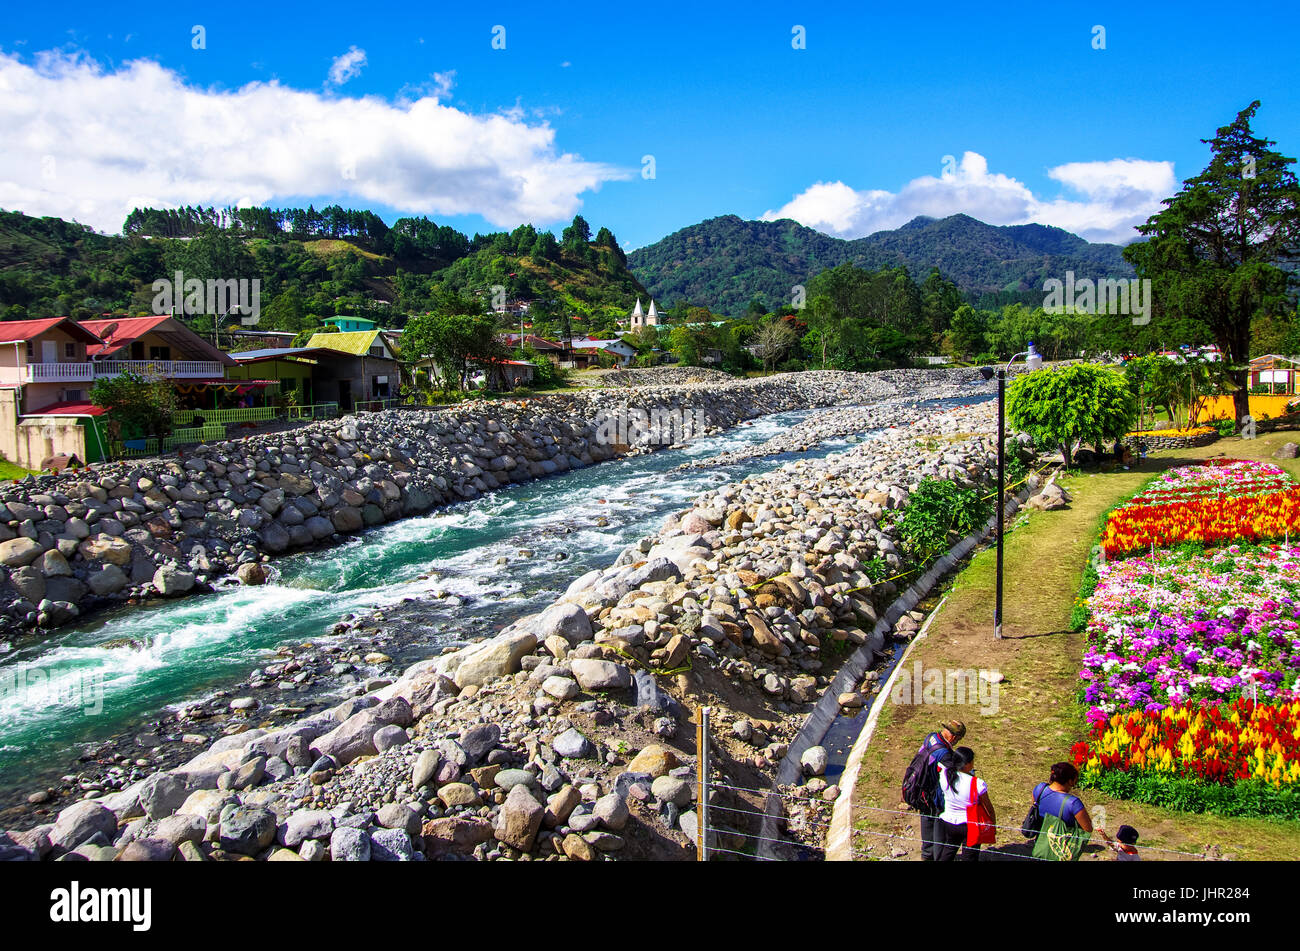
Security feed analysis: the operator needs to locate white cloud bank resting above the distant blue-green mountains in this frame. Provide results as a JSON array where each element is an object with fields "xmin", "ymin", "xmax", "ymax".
[{"xmin": 763, "ymin": 152, "xmax": 1177, "ymax": 243}]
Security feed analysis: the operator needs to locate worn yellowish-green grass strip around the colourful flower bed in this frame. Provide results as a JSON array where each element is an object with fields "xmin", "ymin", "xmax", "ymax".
[{"xmin": 853, "ymin": 433, "xmax": 1300, "ymax": 861}]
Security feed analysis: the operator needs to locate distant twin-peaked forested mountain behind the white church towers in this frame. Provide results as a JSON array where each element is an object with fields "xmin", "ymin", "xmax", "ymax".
[{"xmin": 628, "ymin": 214, "xmax": 1134, "ymax": 316}]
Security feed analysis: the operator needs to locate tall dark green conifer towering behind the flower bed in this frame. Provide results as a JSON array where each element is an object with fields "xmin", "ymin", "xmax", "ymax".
[{"xmin": 1125, "ymin": 100, "xmax": 1300, "ymax": 425}]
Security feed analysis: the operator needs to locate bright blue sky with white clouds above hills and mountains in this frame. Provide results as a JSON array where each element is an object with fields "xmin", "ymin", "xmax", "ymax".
[{"xmin": 0, "ymin": 0, "xmax": 1300, "ymax": 249}]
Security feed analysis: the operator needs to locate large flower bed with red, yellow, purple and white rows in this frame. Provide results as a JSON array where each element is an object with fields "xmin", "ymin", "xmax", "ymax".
[{"xmin": 1074, "ymin": 459, "xmax": 1300, "ymax": 818}]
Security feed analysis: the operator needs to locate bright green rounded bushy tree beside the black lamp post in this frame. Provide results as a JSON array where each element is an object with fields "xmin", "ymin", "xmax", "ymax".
[{"xmin": 1006, "ymin": 364, "xmax": 1138, "ymax": 465}]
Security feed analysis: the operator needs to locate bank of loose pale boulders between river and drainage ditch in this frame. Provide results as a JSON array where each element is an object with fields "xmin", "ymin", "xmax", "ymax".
[{"xmin": 0, "ymin": 394, "xmax": 1034, "ymax": 861}]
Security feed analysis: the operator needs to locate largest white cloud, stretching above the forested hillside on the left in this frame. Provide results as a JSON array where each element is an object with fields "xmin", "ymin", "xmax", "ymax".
[{"xmin": 0, "ymin": 53, "xmax": 632, "ymax": 231}]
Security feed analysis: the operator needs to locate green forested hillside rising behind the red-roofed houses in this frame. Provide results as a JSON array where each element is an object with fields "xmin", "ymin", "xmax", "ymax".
[{"xmin": 0, "ymin": 207, "xmax": 646, "ymax": 331}]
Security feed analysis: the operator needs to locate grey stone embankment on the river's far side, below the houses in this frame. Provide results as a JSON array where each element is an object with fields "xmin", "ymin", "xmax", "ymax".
[{"xmin": 0, "ymin": 370, "xmax": 977, "ymax": 637}]
